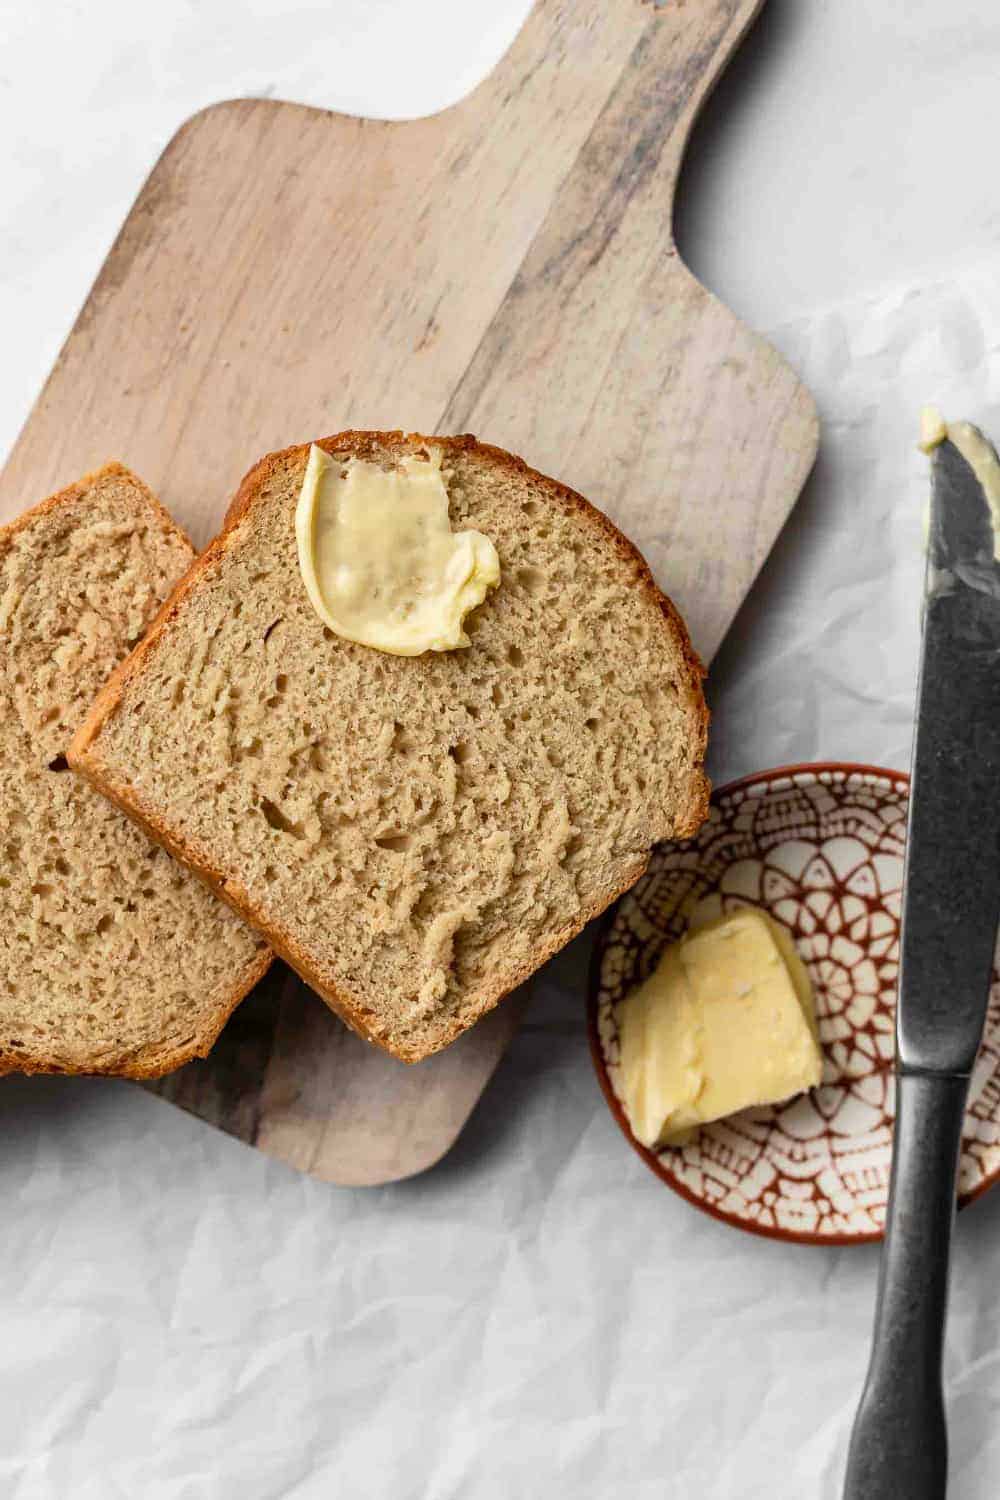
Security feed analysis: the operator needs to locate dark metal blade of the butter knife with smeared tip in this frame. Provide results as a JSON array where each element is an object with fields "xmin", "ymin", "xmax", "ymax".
[{"xmin": 897, "ymin": 423, "xmax": 1000, "ymax": 1073}]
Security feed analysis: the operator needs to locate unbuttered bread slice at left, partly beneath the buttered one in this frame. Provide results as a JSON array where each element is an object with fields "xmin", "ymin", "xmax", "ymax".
[{"xmin": 0, "ymin": 464, "xmax": 270, "ymax": 1079}]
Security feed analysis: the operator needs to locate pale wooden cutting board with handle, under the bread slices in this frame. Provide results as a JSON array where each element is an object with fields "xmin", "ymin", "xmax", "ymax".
[{"xmin": 0, "ymin": 0, "xmax": 817, "ymax": 1184}]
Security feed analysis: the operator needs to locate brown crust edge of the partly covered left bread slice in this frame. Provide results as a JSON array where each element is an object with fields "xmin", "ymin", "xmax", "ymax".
[{"xmin": 0, "ymin": 461, "xmax": 274, "ymax": 1080}]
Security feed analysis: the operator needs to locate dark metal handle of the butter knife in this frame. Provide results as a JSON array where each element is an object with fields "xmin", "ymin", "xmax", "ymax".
[{"xmin": 844, "ymin": 1073, "xmax": 969, "ymax": 1500}]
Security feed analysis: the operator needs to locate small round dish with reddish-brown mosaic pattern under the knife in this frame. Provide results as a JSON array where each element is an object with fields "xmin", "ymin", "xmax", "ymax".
[{"xmin": 589, "ymin": 765, "xmax": 1000, "ymax": 1245}]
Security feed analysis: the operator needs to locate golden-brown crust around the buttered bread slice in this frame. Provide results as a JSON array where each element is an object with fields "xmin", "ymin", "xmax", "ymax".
[{"xmin": 67, "ymin": 429, "xmax": 711, "ymax": 1062}]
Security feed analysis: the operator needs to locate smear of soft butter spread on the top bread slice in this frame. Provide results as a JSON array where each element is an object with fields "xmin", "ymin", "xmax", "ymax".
[{"xmin": 295, "ymin": 444, "xmax": 499, "ymax": 656}]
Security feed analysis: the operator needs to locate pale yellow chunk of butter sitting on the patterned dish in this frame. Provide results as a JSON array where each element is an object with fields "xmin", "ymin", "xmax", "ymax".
[{"xmin": 619, "ymin": 908, "xmax": 823, "ymax": 1146}]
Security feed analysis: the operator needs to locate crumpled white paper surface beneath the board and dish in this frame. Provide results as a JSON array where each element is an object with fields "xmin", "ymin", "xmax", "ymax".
[{"xmin": 0, "ymin": 0, "xmax": 1000, "ymax": 1500}]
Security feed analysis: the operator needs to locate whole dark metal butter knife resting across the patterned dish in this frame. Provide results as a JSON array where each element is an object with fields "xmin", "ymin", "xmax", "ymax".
[{"xmin": 844, "ymin": 423, "xmax": 1000, "ymax": 1500}]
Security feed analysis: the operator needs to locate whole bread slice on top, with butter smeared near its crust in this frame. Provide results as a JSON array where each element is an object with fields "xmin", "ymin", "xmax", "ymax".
[{"xmin": 69, "ymin": 432, "xmax": 708, "ymax": 1061}]
